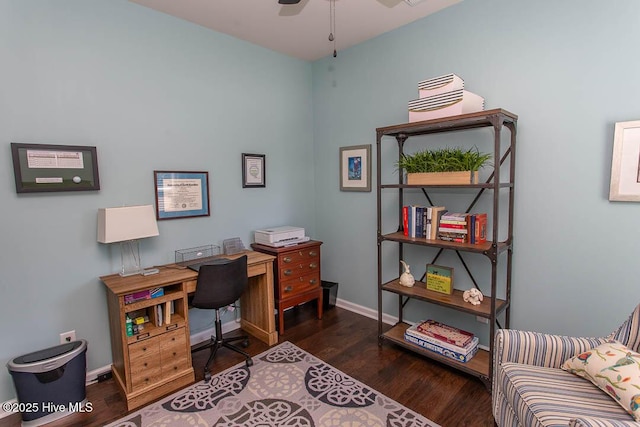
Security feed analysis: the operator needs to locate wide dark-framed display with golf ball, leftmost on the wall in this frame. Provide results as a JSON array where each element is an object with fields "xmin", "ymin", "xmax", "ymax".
[{"xmin": 11, "ymin": 142, "xmax": 100, "ymax": 193}]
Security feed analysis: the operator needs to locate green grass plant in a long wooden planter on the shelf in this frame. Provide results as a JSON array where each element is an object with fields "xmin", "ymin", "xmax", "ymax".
[{"xmin": 396, "ymin": 147, "xmax": 491, "ymax": 185}]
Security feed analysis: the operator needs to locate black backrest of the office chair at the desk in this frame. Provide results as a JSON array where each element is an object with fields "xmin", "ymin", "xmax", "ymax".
[{"xmin": 191, "ymin": 255, "xmax": 248, "ymax": 309}]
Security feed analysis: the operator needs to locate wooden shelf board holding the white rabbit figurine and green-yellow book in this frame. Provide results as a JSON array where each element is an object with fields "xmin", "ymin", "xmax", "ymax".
[{"xmin": 382, "ymin": 279, "xmax": 506, "ymax": 318}]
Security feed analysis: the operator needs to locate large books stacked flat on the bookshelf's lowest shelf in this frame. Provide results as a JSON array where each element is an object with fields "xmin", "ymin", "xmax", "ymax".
[{"xmin": 404, "ymin": 319, "xmax": 478, "ymax": 363}]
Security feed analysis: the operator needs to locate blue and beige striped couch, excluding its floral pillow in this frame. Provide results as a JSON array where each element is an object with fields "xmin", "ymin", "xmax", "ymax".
[{"xmin": 492, "ymin": 305, "xmax": 640, "ymax": 427}]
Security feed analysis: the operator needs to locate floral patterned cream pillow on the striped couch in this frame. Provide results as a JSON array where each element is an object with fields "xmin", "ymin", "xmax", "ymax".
[{"xmin": 562, "ymin": 341, "xmax": 640, "ymax": 421}]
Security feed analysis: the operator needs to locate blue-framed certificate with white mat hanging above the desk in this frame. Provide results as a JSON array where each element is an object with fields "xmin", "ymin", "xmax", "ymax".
[{"xmin": 153, "ymin": 171, "xmax": 210, "ymax": 220}]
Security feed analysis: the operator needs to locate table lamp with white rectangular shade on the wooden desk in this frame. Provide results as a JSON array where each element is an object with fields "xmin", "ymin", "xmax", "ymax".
[{"xmin": 98, "ymin": 205, "xmax": 160, "ymax": 277}]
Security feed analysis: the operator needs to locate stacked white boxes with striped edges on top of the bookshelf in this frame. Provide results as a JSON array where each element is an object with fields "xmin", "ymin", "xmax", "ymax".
[{"xmin": 409, "ymin": 74, "xmax": 484, "ymax": 122}]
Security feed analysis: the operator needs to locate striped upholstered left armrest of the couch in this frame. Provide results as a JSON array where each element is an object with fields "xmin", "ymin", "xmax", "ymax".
[{"xmin": 493, "ymin": 329, "xmax": 606, "ymax": 370}]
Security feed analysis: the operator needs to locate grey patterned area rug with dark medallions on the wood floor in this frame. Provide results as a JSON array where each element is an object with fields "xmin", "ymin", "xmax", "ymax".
[{"xmin": 108, "ymin": 342, "xmax": 438, "ymax": 427}]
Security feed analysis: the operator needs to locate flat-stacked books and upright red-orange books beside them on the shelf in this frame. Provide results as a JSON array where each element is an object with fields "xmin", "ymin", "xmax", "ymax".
[{"xmin": 437, "ymin": 212, "xmax": 487, "ymax": 245}]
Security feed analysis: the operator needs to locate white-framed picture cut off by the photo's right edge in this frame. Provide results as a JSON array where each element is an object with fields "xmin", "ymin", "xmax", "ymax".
[{"xmin": 609, "ymin": 120, "xmax": 640, "ymax": 202}]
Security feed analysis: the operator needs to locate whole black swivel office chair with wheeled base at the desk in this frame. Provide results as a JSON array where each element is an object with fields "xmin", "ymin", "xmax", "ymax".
[{"xmin": 191, "ymin": 255, "xmax": 253, "ymax": 381}]
